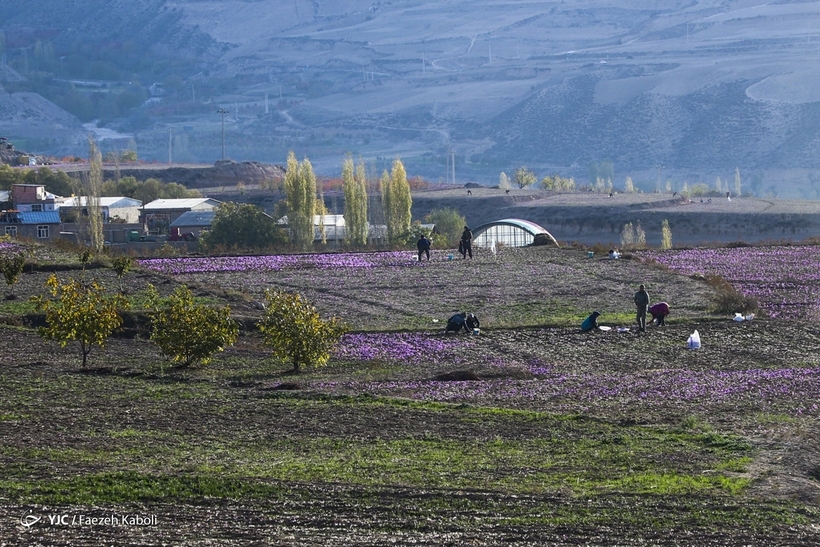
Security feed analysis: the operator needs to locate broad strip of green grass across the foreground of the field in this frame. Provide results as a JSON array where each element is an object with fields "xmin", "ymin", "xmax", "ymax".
[{"xmin": 0, "ymin": 394, "xmax": 751, "ymax": 506}]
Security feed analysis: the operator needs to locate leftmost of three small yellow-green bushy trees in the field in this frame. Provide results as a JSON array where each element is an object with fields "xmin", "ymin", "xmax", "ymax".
[{"xmin": 34, "ymin": 274, "xmax": 128, "ymax": 368}]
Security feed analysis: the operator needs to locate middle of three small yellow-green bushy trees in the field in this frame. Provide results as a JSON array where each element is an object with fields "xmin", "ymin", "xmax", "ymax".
[{"xmin": 148, "ymin": 285, "xmax": 239, "ymax": 368}]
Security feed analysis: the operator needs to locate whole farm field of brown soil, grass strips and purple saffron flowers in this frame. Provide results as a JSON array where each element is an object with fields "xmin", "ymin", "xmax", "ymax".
[{"xmin": 0, "ymin": 249, "xmax": 820, "ymax": 546}]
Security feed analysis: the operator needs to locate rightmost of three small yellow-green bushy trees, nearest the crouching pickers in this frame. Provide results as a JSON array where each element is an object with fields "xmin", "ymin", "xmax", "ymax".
[{"xmin": 258, "ymin": 289, "xmax": 347, "ymax": 374}]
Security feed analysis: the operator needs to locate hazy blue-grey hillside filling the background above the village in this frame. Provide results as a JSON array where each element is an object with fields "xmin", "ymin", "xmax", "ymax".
[{"xmin": 0, "ymin": 0, "xmax": 820, "ymax": 198}]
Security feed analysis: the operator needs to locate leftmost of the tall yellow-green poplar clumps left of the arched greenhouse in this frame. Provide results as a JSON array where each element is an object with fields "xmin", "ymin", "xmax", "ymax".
[{"xmin": 285, "ymin": 152, "xmax": 316, "ymax": 249}]
